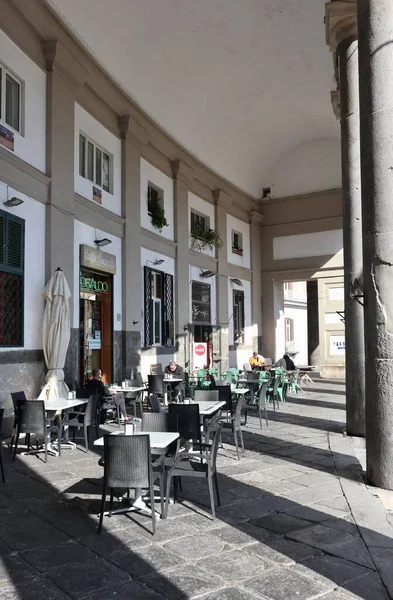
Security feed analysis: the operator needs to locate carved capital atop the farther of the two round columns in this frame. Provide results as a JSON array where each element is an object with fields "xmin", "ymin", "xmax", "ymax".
[{"xmin": 325, "ymin": 0, "xmax": 358, "ymax": 52}]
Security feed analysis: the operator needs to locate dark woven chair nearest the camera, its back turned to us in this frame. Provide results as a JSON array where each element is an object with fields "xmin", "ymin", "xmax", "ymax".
[{"xmin": 98, "ymin": 434, "xmax": 159, "ymax": 535}]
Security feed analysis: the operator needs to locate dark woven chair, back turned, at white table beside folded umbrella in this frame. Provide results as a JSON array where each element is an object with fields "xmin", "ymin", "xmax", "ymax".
[{"xmin": 12, "ymin": 400, "xmax": 50, "ymax": 462}]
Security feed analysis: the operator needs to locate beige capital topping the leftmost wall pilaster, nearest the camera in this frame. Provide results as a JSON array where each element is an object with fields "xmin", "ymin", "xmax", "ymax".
[{"xmin": 42, "ymin": 40, "xmax": 89, "ymax": 89}]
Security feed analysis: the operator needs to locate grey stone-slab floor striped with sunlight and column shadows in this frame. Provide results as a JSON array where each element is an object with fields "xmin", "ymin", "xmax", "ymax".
[{"xmin": 0, "ymin": 381, "xmax": 393, "ymax": 600}]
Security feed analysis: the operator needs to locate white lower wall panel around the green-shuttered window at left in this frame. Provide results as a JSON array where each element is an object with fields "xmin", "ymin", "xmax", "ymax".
[{"xmin": 0, "ymin": 182, "xmax": 46, "ymax": 352}]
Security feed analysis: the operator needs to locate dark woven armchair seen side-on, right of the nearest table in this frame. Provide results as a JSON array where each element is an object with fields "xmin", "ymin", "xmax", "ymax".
[{"xmin": 165, "ymin": 424, "xmax": 221, "ymax": 519}]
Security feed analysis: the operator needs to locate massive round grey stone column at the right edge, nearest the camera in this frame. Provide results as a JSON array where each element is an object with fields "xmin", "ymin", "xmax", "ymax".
[{"xmin": 358, "ymin": 0, "xmax": 393, "ymax": 490}]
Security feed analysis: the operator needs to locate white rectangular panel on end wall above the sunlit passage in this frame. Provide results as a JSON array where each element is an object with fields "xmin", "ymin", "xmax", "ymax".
[{"xmin": 273, "ymin": 229, "xmax": 343, "ymax": 260}]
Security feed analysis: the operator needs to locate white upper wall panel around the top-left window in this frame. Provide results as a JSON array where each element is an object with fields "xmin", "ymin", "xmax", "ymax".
[{"xmin": 0, "ymin": 30, "xmax": 46, "ymax": 173}]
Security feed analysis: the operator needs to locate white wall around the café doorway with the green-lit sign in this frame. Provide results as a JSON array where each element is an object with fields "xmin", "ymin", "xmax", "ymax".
[{"xmin": 73, "ymin": 220, "xmax": 122, "ymax": 331}]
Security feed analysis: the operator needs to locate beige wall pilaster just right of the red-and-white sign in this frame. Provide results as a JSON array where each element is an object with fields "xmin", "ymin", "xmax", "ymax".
[{"xmin": 212, "ymin": 189, "xmax": 232, "ymax": 373}]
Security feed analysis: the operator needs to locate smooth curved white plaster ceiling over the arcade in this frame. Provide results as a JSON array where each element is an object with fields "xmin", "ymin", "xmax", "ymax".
[{"xmin": 48, "ymin": 0, "xmax": 339, "ymax": 197}]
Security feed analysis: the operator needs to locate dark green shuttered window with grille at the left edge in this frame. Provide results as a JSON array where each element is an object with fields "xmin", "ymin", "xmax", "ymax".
[{"xmin": 0, "ymin": 211, "xmax": 25, "ymax": 348}]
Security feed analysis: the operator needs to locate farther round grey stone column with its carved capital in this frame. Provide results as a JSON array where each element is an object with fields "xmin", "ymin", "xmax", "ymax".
[{"xmin": 326, "ymin": 2, "xmax": 366, "ymax": 436}]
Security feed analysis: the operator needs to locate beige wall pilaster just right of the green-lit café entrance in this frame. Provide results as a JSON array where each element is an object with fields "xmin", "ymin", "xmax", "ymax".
[{"xmin": 115, "ymin": 115, "xmax": 148, "ymax": 380}]
